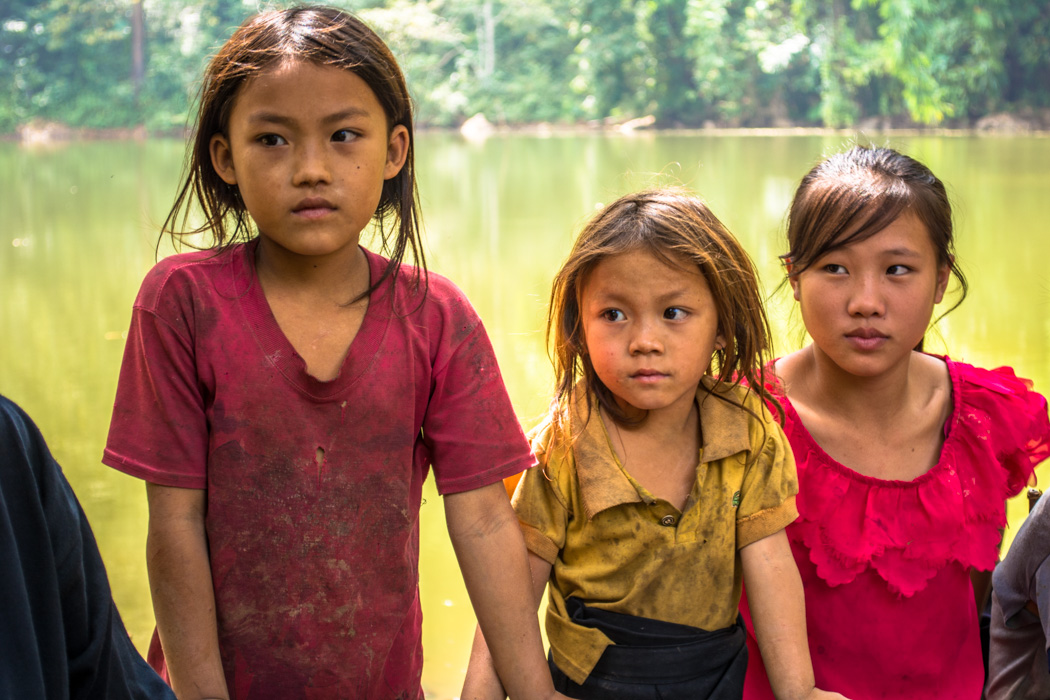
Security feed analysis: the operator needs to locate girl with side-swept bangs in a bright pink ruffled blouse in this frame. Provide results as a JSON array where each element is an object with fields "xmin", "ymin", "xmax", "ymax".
[{"xmin": 741, "ymin": 147, "xmax": 1050, "ymax": 700}]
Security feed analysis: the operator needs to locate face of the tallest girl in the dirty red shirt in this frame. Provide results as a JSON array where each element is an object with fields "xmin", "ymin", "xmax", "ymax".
[{"xmin": 211, "ymin": 61, "xmax": 408, "ymax": 261}]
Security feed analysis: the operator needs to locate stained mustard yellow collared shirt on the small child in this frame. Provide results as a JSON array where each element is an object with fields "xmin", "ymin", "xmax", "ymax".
[{"xmin": 513, "ymin": 378, "xmax": 798, "ymax": 683}]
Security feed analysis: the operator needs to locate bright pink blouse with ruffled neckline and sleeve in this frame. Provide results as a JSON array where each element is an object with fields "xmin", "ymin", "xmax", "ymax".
[{"xmin": 740, "ymin": 358, "xmax": 1050, "ymax": 700}]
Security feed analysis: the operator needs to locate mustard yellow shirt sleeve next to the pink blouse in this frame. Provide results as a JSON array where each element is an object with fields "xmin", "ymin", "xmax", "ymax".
[{"xmin": 736, "ymin": 410, "xmax": 798, "ymax": 549}]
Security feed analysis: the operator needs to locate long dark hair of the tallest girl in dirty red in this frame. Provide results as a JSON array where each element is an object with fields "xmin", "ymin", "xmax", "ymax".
[{"xmin": 162, "ymin": 5, "xmax": 426, "ymax": 295}]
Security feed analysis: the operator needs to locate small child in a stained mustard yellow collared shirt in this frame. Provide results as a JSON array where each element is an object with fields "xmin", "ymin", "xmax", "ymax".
[{"xmin": 463, "ymin": 190, "xmax": 841, "ymax": 700}]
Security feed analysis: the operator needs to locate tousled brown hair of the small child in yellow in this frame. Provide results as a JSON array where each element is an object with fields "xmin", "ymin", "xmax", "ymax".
[{"xmin": 547, "ymin": 188, "xmax": 779, "ymax": 440}]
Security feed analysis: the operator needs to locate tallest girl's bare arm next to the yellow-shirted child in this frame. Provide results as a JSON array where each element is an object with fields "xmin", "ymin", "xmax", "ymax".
[{"xmin": 445, "ymin": 483, "xmax": 562, "ymax": 699}]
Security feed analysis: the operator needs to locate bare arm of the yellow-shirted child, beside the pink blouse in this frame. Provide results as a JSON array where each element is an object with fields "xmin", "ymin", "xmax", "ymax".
[{"xmin": 740, "ymin": 530, "xmax": 843, "ymax": 700}]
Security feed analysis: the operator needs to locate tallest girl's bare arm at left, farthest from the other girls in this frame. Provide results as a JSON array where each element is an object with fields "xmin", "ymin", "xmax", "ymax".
[{"xmin": 146, "ymin": 484, "xmax": 229, "ymax": 700}]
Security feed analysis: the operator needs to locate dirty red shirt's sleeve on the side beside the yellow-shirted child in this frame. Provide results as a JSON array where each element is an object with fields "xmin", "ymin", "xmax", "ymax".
[{"xmin": 423, "ymin": 287, "xmax": 536, "ymax": 495}]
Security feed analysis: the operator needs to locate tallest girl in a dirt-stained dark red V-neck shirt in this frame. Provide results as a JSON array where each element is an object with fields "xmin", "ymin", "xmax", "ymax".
[{"xmin": 103, "ymin": 7, "xmax": 557, "ymax": 699}]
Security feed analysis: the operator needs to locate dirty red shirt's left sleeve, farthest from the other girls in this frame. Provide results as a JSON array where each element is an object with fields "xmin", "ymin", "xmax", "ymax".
[{"xmin": 102, "ymin": 268, "xmax": 208, "ymax": 489}]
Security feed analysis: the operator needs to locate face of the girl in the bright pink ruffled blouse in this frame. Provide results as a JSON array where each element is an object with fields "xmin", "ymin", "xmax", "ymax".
[{"xmin": 790, "ymin": 212, "xmax": 949, "ymax": 377}]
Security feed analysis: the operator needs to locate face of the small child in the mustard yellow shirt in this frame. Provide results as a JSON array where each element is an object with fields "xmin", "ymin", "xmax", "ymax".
[{"xmin": 580, "ymin": 250, "xmax": 726, "ymax": 417}]
